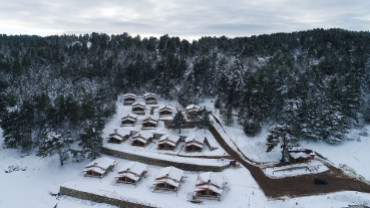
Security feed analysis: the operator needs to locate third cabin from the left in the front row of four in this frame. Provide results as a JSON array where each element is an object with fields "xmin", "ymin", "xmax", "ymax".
[{"xmin": 153, "ymin": 166, "xmax": 184, "ymax": 191}]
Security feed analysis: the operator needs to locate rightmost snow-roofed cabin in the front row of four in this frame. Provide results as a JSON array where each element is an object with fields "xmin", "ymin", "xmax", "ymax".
[{"xmin": 194, "ymin": 172, "xmax": 224, "ymax": 200}]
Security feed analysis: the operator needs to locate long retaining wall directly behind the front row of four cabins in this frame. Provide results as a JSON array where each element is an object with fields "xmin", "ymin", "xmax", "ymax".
[{"xmin": 102, "ymin": 147, "xmax": 229, "ymax": 172}]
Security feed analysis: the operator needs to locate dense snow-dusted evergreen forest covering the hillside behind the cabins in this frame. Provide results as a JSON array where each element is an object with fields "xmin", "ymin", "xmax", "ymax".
[{"xmin": 0, "ymin": 29, "xmax": 370, "ymax": 160}]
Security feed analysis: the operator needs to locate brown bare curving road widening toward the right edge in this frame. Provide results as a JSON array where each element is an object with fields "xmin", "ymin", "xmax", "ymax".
[{"xmin": 209, "ymin": 125, "xmax": 370, "ymax": 198}]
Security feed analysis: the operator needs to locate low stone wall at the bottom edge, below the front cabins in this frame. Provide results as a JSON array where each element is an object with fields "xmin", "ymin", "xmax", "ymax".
[{"xmin": 59, "ymin": 186, "xmax": 156, "ymax": 208}]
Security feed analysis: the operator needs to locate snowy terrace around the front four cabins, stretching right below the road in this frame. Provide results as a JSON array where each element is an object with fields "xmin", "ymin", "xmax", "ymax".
[{"xmin": 62, "ymin": 156, "xmax": 370, "ymax": 208}]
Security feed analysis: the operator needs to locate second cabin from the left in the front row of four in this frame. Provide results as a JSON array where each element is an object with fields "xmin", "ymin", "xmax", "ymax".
[{"xmin": 115, "ymin": 162, "xmax": 148, "ymax": 186}]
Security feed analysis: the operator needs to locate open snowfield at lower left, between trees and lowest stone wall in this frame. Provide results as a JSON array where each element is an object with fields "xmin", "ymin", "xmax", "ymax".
[{"xmin": 0, "ymin": 129, "xmax": 112, "ymax": 208}]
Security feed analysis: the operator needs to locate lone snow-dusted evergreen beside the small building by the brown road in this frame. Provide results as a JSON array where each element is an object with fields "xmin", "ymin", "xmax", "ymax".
[{"xmin": 266, "ymin": 125, "xmax": 299, "ymax": 162}]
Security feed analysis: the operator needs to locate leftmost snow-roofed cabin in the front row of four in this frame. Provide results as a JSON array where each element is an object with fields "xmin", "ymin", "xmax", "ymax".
[{"xmin": 82, "ymin": 157, "xmax": 116, "ymax": 178}]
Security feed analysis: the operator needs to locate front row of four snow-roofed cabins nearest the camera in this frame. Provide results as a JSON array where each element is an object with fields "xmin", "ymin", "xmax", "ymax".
[{"xmin": 82, "ymin": 157, "xmax": 224, "ymax": 200}]
